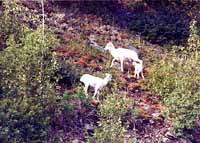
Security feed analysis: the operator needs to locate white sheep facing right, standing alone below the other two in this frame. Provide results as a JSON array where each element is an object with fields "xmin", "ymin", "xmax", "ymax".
[{"xmin": 80, "ymin": 73, "xmax": 112, "ymax": 99}]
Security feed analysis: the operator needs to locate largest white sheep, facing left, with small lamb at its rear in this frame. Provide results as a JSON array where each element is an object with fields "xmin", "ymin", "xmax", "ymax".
[{"xmin": 105, "ymin": 42, "xmax": 142, "ymax": 72}]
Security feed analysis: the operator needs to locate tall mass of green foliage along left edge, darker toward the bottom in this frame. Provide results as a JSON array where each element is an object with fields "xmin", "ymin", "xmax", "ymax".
[{"xmin": 0, "ymin": 25, "xmax": 57, "ymax": 142}]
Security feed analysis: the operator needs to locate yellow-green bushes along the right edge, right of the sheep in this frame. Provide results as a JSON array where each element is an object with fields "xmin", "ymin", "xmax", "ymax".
[{"xmin": 145, "ymin": 20, "xmax": 200, "ymax": 135}]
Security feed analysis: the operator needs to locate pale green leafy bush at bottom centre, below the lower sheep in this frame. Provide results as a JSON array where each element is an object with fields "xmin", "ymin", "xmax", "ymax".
[{"xmin": 88, "ymin": 94, "xmax": 138, "ymax": 143}]
